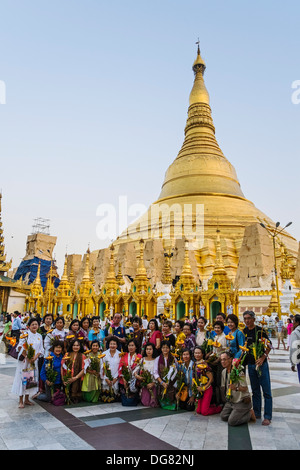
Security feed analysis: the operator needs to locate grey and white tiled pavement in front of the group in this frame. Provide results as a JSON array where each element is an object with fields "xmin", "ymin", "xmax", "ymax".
[{"xmin": 0, "ymin": 349, "xmax": 300, "ymax": 451}]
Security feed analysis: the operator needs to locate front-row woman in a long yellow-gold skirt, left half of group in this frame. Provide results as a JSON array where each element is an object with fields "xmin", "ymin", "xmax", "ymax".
[{"xmin": 81, "ymin": 339, "xmax": 101, "ymax": 403}]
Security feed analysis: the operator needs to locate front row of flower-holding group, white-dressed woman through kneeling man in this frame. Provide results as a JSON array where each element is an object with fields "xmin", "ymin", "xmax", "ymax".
[{"xmin": 13, "ymin": 318, "xmax": 255, "ymax": 426}]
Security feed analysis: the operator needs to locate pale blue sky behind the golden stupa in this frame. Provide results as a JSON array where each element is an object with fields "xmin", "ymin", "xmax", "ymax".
[{"xmin": 0, "ymin": 0, "xmax": 300, "ymax": 274}]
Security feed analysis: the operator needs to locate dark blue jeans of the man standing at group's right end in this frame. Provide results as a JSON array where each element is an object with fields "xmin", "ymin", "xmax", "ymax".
[{"xmin": 248, "ymin": 361, "xmax": 273, "ymax": 420}]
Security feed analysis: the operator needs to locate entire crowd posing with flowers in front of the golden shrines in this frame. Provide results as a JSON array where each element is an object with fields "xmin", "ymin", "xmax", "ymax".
[{"xmin": 3, "ymin": 311, "xmax": 300, "ymax": 426}]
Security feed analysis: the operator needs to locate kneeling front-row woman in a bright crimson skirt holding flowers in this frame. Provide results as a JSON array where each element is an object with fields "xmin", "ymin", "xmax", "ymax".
[{"xmin": 193, "ymin": 346, "xmax": 222, "ymax": 416}]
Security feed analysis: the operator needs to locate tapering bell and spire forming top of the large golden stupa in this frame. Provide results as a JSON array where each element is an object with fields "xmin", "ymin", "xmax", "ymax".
[{"xmin": 157, "ymin": 41, "xmax": 244, "ymax": 203}]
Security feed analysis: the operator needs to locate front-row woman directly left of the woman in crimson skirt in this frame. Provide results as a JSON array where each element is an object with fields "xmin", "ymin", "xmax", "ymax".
[{"xmin": 176, "ymin": 349, "xmax": 195, "ymax": 411}]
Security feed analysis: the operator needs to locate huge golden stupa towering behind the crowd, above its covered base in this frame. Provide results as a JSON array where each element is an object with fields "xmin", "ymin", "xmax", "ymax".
[{"xmin": 115, "ymin": 45, "xmax": 298, "ymax": 279}]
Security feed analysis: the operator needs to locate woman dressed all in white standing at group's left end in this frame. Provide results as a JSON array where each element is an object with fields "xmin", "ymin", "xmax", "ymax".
[{"xmin": 12, "ymin": 317, "xmax": 44, "ymax": 408}]
